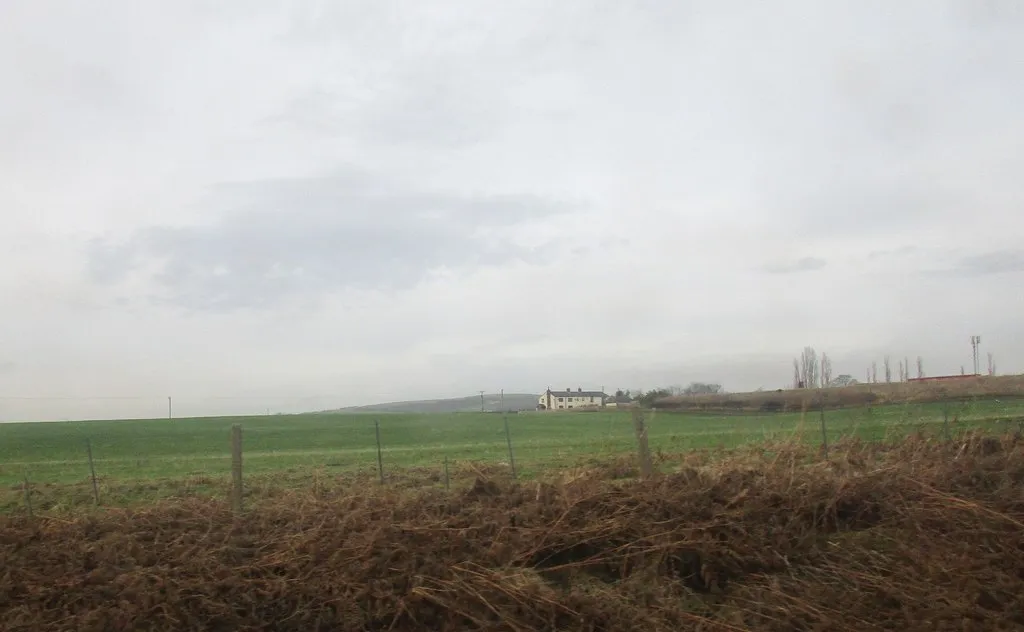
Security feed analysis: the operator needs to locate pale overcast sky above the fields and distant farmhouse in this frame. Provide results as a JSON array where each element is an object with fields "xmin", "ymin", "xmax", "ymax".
[{"xmin": 0, "ymin": 0, "xmax": 1024, "ymax": 419}]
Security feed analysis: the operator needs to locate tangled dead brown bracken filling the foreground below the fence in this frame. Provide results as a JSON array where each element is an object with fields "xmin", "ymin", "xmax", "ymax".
[{"xmin": 0, "ymin": 436, "xmax": 1024, "ymax": 632}]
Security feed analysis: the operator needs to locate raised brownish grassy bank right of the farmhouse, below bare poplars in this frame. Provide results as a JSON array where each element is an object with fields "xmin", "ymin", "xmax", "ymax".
[{"xmin": 654, "ymin": 375, "xmax": 1024, "ymax": 413}]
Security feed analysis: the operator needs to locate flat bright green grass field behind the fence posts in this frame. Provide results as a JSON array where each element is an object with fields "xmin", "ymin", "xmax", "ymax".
[{"xmin": 0, "ymin": 401, "xmax": 1024, "ymax": 488}]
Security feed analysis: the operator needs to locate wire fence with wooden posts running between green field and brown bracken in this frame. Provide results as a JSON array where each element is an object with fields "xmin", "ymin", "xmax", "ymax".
[{"xmin": 0, "ymin": 398, "xmax": 1024, "ymax": 513}]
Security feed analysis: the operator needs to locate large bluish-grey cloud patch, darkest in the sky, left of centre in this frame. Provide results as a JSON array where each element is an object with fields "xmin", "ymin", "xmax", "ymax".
[{"xmin": 89, "ymin": 173, "xmax": 575, "ymax": 310}]
